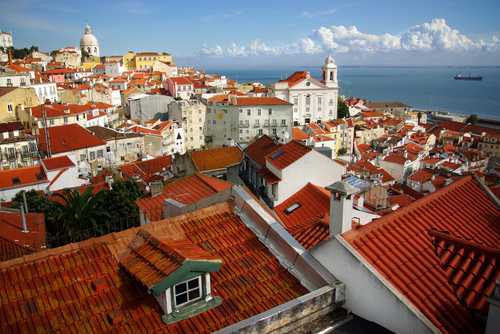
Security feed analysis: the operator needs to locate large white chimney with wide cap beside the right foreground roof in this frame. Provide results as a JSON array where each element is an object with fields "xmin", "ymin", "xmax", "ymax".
[{"xmin": 326, "ymin": 181, "xmax": 359, "ymax": 237}]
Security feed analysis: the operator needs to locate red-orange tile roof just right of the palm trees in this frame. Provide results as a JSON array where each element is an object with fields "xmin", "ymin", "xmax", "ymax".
[{"xmin": 136, "ymin": 173, "xmax": 232, "ymax": 221}]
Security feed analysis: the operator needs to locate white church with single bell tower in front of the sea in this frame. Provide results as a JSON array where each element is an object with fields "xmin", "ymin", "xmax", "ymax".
[{"xmin": 272, "ymin": 56, "xmax": 339, "ymax": 126}]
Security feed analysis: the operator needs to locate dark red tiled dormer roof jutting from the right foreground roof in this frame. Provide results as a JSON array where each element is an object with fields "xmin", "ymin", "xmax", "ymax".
[{"xmin": 429, "ymin": 230, "xmax": 500, "ymax": 316}]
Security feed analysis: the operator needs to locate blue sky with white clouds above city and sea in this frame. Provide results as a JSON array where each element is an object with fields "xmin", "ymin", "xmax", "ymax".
[{"xmin": 0, "ymin": 0, "xmax": 500, "ymax": 67}]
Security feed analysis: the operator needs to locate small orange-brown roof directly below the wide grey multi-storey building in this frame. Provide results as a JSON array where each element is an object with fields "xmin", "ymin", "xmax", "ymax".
[{"xmin": 190, "ymin": 147, "xmax": 243, "ymax": 172}]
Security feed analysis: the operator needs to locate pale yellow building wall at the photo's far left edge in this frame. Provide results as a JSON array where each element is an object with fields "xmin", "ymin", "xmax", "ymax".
[{"xmin": 0, "ymin": 87, "xmax": 40, "ymax": 123}]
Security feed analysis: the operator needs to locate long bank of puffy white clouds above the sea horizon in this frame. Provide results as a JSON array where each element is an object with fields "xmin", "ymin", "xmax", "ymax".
[{"xmin": 200, "ymin": 18, "xmax": 500, "ymax": 57}]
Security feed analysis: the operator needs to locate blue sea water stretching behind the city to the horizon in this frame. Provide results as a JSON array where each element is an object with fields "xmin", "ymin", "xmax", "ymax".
[{"xmin": 207, "ymin": 66, "xmax": 500, "ymax": 120}]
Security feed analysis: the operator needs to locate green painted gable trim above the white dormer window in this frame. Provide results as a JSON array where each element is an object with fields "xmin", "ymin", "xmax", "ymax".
[{"xmin": 150, "ymin": 260, "xmax": 222, "ymax": 296}]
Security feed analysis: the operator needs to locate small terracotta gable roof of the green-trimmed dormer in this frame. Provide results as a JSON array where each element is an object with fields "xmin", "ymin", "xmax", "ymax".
[{"xmin": 120, "ymin": 230, "xmax": 220, "ymax": 289}]
